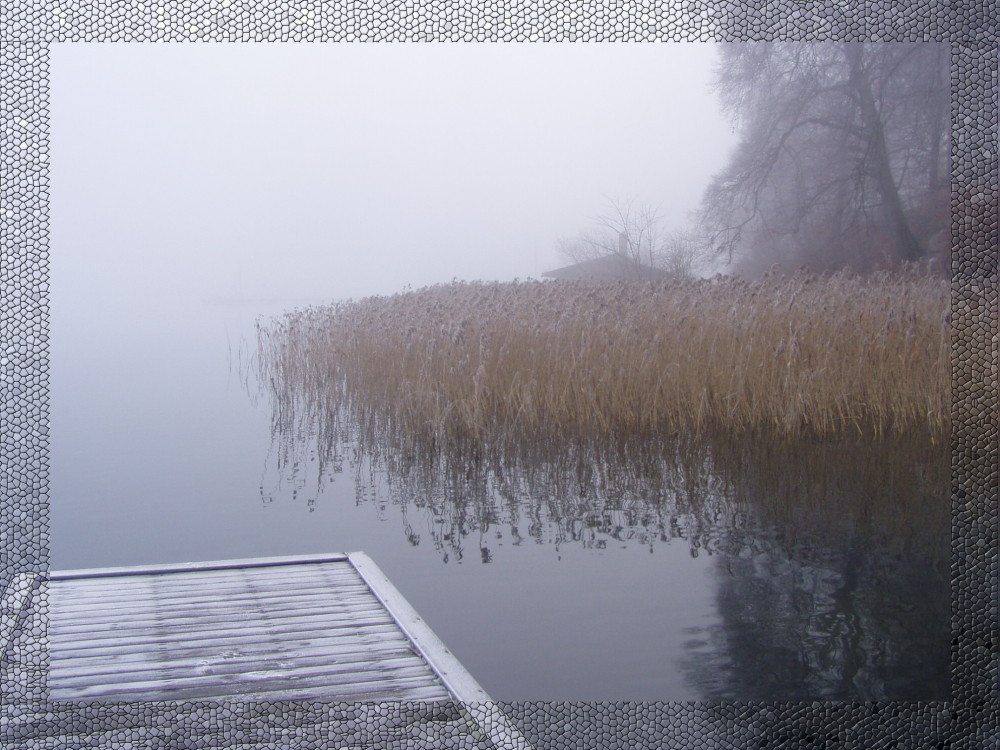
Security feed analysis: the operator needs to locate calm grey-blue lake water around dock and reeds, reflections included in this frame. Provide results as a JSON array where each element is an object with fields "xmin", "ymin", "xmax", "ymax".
[{"xmin": 50, "ymin": 301, "xmax": 950, "ymax": 701}]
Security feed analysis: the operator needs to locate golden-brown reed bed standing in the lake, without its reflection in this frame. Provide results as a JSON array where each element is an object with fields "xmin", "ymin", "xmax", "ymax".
[{"xmin": 258, "ymin": 274, "xmax": 951, "ymax": 452}]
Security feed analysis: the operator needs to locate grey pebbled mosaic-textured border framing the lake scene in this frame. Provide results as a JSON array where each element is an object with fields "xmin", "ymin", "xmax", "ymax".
[{"xmin": 0, "ymin": 0, "xmax": 1000, "ymax": 749}]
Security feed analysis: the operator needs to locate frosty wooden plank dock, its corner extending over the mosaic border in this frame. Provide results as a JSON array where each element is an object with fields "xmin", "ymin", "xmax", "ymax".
[{"xmin": 0, "ymin": 552, "xmax": 528, "ymax": 748}]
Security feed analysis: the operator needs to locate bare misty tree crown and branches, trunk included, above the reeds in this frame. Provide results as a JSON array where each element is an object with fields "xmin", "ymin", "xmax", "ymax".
[{"xmin": 701, "ymin": 42, "xmax": 950, "ymax": 274}]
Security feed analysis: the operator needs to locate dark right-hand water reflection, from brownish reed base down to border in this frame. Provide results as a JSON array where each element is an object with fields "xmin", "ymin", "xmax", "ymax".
[{"xmin": 672, "ymin": 438, "xmax": 950, "ymax": 700}]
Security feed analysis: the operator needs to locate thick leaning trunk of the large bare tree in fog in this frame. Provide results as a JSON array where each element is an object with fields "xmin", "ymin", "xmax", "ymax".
[{"xmin": 841, "ymin": 42, "xmax": 924, "ymax": 261}]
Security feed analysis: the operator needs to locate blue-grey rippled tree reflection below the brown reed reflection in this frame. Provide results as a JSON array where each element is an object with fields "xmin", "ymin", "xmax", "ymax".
[{"xmin": 684, "ymin": 528, "xmax": 949, "ymax": 700}]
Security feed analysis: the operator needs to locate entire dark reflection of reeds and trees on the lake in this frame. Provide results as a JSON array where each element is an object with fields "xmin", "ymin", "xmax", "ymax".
[{"xmin": 264, "ymin": 378, "xmax": 950, "ymax": 700}]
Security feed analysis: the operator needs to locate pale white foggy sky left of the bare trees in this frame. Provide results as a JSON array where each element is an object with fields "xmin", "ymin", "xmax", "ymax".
[{"xmin": 51, "ymin": 43, "xmax": 734, "ymax": 307}]
